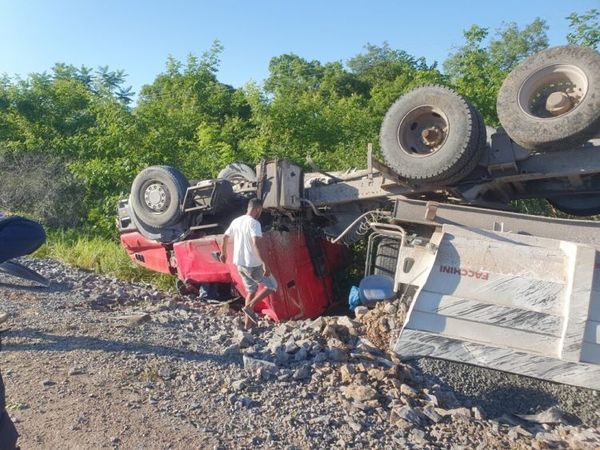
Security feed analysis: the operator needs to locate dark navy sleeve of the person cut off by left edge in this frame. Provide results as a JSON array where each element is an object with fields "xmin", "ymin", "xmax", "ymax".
[{"xmin": 0, "ymin": 216, "xmax": 46, "ymax": 263}]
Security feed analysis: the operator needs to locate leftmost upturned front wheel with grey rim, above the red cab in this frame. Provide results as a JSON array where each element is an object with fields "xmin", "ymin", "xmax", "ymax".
[{"xmin": 130, "ymin": 166, "xmax": 189, "ymax": 228}]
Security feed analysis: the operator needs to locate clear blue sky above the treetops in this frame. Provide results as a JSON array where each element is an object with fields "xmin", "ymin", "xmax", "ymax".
[{"xmin": 0, "ymin": 0, "xmax": 600, "ymax": 92}]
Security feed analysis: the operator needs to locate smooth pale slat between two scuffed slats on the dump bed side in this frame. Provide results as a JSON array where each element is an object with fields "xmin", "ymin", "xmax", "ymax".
[{"xmin": 405, "ymin": 310, "xmax": 560, "ymax": 357}]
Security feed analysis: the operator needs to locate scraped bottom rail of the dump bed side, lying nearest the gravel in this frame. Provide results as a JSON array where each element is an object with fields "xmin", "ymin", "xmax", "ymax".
[{"xmin": 394, "ymin": 330, "xmax": 600, "ymax": 389}]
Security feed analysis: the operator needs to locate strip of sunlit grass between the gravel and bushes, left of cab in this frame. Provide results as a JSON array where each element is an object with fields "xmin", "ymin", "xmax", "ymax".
[{"xmin": 33, "ymin": 230, "xmax": 175, "ymax": 290}]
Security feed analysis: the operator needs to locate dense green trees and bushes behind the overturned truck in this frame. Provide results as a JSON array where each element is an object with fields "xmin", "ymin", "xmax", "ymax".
[{"xmin": 0, "ymin": 13, "xmax": 599, "ymax": 246}]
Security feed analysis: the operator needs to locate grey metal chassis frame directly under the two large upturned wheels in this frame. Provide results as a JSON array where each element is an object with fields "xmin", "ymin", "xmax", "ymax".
[{"xmin": 305, "ymin": 133, "xmax": 600, "ymax": 207}]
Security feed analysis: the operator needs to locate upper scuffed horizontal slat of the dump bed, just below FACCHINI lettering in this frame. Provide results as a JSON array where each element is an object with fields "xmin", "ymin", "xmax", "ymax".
[{"xmin": 414, "ymin": 291, "xmax": 563, "ymax": 337}]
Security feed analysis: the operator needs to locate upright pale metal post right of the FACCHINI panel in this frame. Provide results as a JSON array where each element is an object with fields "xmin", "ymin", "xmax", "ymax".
[{"xmin": 561, "ymin": 242, "xmax": 596, "ymax": 361}]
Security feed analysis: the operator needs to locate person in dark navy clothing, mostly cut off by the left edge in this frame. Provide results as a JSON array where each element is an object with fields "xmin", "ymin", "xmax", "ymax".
[{"xmin": 0, "ymin": 212, "xmax": 46, "ymax": 450}]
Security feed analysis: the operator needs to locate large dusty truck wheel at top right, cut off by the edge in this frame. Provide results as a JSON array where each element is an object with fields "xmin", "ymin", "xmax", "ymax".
[{"xmin": 496, "ymin": 46, "xmax": 600, "ymax": 150}]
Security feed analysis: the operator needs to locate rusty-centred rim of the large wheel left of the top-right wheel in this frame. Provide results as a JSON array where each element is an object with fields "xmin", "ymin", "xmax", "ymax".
[{"xmin": 397, "ymin": 105, "xmax": 449, "ymax": 157}]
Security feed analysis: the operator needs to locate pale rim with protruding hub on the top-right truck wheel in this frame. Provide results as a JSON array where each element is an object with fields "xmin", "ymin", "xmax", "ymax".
[{"xmin": 518, "ymin": 64, "xmax": 588, "ymax": 119}]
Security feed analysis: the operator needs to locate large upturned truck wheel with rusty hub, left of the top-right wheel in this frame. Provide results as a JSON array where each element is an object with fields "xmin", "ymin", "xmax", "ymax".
[{"xmin": 379, "ymin": 86, "xmax": 485, "ymax": 185}]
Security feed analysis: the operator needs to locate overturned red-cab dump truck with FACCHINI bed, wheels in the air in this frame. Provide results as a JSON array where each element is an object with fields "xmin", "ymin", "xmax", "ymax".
[{"xmin": 118, "ymin": 46, "xmax": 600, "ymax": 389}]
